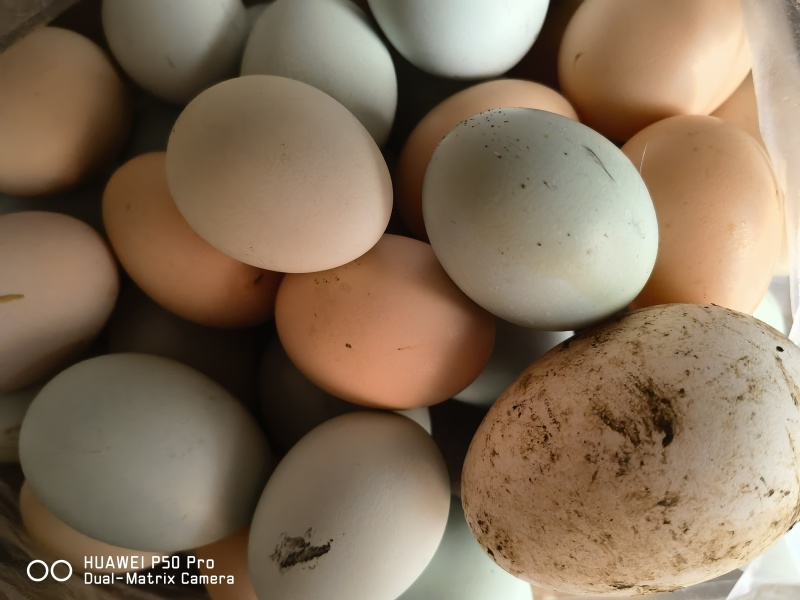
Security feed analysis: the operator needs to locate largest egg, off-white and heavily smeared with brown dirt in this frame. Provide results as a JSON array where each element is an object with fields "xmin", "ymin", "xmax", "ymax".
[{"xmin": 462, "ymin": 304, "xmax": 800, "ymax": 596}]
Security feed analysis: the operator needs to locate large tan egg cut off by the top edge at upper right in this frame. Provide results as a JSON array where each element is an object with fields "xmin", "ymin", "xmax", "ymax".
[{"xmin": 558, "ymin": 0, "xmax": 751, "ymax": 141}]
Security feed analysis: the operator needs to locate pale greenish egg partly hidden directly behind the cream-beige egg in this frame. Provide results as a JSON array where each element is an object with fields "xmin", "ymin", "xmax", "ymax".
[{"xmin": 241, "ymin": 0, "xmax": 397, "ymax": 146}]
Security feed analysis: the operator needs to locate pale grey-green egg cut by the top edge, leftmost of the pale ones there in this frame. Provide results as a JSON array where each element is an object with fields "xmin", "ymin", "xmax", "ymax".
[{"xmin": 102, "ymin": 0, "xmax": 247, "ymax": 105}]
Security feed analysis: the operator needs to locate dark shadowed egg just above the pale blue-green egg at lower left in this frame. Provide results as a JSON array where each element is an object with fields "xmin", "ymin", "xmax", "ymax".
[{"xmin": 107, "ymin": 287, "xmax": 260, "ymax": 408}]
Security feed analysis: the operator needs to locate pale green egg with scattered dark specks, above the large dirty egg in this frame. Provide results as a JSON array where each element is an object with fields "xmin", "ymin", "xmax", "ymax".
[{"xmin": 422, "ymin": 108, "xmax": 658, "ymax": 331}]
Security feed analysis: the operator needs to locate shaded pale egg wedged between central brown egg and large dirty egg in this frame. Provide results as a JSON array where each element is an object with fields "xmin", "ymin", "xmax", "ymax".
[{"xmin": 453, "ymin": 319, "xmax": 573, "ymax": 406}]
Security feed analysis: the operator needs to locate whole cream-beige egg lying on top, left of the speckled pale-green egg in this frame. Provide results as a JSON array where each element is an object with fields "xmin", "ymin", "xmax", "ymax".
[{"xmin": 167, "ymin": 75, "xmax": 392, "ymax": 273}]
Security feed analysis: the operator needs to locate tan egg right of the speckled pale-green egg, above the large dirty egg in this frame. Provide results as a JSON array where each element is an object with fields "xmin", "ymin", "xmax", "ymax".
[{"xmin": 622, "ymin": 116, "xmax": 783, "ymax": 314}]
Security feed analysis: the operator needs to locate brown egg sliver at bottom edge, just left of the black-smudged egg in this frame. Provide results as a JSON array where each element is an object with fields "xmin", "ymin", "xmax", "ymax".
[{"xmin": 194, "ymin": 526, "xmax": 258, "ymax": 600}]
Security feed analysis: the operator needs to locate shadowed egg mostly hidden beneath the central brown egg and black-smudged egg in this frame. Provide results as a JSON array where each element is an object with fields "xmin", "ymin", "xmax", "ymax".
[{"xmin": 259, "ymin": 338, "xmax": 431, "ymax": 453}]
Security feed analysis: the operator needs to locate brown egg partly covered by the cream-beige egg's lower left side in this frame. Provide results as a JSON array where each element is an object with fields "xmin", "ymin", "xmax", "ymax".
[{"xmin": 103, "ymin": 152, "xmax": 280, "ymax": 327}]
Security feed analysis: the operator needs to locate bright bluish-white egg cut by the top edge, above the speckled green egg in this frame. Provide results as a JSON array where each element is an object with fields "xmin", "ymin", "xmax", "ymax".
[{"xmin": 368, "ymin": 0, "xmax": 549, "ymax": 79}]
